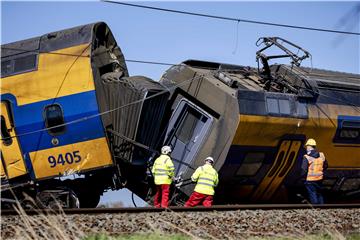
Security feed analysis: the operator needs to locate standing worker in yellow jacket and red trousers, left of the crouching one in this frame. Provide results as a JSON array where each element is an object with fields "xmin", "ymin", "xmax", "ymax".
[{"xmin": 151, "ymin": 146, "xmax": 175, "ymax": 208}]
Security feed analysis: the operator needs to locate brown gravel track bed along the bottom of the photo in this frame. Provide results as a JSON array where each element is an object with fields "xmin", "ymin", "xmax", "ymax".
[{"xmin": 1, "ymin": 204, "xmax": 360, "ymax": 239}]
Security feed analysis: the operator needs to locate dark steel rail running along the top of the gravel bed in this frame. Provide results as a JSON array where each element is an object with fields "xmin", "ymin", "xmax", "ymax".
[{"xmin": 1, "ymin": 204, "xmax": 360, "ymax": 216}]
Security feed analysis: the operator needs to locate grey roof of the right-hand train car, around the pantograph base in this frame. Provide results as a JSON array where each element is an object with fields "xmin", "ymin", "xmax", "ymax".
[{"xmin": 182, "ymin": 60, "xmax": 360, "ymax": 91}]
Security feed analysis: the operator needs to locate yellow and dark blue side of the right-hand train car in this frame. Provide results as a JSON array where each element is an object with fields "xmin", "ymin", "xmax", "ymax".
[{"xmin": 221, "ymin": 93, "xmax": 360, "ymax": 202}]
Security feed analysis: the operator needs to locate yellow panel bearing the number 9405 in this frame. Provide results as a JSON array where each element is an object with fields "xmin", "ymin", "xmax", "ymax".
[{"xmin": 30, "ymin": 138, "xmax": 113, "ymax": 179}]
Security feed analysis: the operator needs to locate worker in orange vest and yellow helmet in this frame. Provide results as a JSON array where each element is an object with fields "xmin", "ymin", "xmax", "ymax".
[{"xmin": 301, "ymin": 138, "xmax": 328, "ymax": 204}]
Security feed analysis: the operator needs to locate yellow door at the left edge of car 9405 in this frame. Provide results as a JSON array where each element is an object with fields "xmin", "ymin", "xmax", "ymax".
[{"xmin": 0, "ymin": 101, "xmax": 27, "ymax": 179}]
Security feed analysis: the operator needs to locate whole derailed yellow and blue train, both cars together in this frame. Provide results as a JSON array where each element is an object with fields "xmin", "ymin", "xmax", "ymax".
[{"xmin": 1, "ymin": 23, "xmax": 360, "ymax": 207}]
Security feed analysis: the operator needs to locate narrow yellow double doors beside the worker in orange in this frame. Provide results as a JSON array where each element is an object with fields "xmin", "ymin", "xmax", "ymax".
[{"xmin": 252, "ymin": 140, "xmax": 302, "ymax": 201}]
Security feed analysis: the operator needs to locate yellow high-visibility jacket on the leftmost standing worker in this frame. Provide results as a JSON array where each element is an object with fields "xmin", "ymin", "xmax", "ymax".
[{"xmin": 151, "ymin": 154, "xmax": 175, "ymax": 185}]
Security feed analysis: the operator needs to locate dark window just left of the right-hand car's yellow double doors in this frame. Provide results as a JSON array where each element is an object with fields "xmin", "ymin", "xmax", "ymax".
[{"xmin": 236, "ymin": 152, "xmax": 265, "ymax": 176}]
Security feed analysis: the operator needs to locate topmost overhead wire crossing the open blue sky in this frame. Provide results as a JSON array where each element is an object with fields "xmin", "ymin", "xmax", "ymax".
[{"xmin": 101, "ymin": 0, "xmax": 360, "ymax": 36}]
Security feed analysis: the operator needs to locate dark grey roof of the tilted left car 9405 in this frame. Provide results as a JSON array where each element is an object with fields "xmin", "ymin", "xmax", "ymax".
[{"xmin": 1, "ymin": 22, "xmax": 128, "ymax": 77}]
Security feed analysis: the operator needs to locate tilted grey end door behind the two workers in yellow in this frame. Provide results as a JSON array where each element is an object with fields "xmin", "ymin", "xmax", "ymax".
[{"xmin": 165, "ymin": 99, "xmax": 213, "ymax": 175}]
